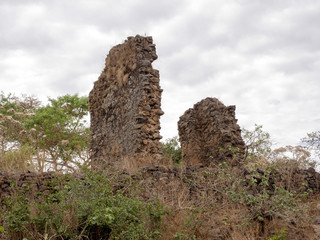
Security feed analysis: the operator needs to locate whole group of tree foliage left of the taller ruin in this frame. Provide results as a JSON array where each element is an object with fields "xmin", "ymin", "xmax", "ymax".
[{"xmin": 0, "ymin": 93, "xmax": 90, "ymax": 172}]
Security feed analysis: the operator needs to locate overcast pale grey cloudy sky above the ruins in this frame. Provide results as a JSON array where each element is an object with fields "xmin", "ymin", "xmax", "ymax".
[{"xmin": 0, "ymin": 0, "xmax": 320, "ymax": 145}]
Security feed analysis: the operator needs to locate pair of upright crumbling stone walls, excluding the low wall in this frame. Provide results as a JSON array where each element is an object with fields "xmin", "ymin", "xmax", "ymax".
[{"xmin": 89, "ymin": 35, "xmax": 245, "ymax": 169}]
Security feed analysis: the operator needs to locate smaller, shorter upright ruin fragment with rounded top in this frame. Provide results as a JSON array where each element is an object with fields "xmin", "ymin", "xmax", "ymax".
[{"xmin": 178, "ymin": 98, "xmax": 245, "ymax": 166}]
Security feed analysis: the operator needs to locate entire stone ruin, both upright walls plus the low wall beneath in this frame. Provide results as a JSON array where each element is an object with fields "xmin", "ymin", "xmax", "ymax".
[{"xmin": 0, "ymin": 36, "xmax": 320, "ymax": 236}]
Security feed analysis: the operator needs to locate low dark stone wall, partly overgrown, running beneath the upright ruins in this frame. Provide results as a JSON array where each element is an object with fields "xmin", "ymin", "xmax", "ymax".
[{"xmin": 0, "ymin": 165, "xmax": 320, "ymax": 202}]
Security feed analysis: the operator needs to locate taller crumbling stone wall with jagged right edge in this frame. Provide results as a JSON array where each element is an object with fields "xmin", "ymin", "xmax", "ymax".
[{"xmin": 89, "ymin": 35, "xmax": 163, "ymax": 168}]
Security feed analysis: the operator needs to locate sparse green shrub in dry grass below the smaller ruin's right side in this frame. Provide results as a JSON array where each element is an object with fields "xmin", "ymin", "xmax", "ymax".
[{"xmin": 219, "ymin": 164, "xmax": 308, "ymax": 223}]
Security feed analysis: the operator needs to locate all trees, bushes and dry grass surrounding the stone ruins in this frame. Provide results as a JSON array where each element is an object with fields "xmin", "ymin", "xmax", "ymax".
[{"xmin": 0, "ymin": 93, "xmax": 320, "ymax": 240}]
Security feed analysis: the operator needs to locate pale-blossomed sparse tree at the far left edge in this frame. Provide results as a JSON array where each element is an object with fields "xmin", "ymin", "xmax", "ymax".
[{"xmin": 0, "ymin": 92, "xmax": 40, "ymax": 171}]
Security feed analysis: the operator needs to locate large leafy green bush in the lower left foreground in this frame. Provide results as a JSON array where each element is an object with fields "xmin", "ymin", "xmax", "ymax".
[{"xmin": 1, "ymin": 170, "xmax": 166, "ymax": 239}]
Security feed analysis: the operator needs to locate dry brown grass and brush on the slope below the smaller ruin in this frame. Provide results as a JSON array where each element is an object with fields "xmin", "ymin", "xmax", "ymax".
[{"xmin": 124, "ymin": 157, "xmax": 320, "ymax": 240}]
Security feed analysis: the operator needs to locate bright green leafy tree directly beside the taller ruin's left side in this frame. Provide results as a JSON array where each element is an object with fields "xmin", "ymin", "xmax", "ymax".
[{"xmin": 27, "ymin": 94, "xmax": 89, "ymax": 171}]
